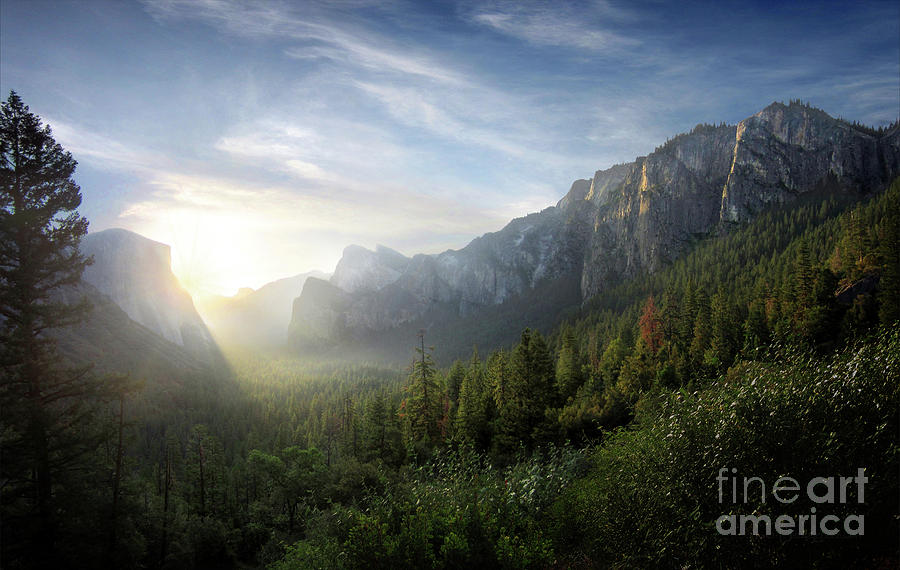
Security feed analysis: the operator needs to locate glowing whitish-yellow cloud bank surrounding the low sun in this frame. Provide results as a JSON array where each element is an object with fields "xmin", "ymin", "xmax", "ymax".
[{"xmin": 55, "ymin": 117, "xmax": 520, "ymax": 292}]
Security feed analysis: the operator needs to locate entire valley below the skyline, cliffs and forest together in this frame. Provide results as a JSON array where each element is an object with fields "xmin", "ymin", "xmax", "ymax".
[{"xmin": 3, "ymin": 92, "xmax": 900, "ymax": 569}]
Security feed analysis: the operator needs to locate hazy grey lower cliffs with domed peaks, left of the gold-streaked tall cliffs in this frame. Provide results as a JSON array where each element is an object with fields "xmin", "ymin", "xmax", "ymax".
[{"xmin": 290, "ymin": 201, "xmax": 591, "ymax": 346}]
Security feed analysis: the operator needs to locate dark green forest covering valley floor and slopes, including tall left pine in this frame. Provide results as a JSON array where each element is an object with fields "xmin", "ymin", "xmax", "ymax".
[{"xmin": 0, "ymin": 90, "xmax": 900, "ymax": 570}]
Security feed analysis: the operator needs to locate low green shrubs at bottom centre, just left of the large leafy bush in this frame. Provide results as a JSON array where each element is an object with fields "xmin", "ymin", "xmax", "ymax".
[{"xmin": 271, "ymin": 447, "xmax": 586, "ymax": 570}]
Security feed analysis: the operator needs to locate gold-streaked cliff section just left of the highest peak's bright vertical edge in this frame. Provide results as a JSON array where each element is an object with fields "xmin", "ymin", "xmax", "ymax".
[{"xmin": 581, "ymin": 125, "xmax": 736, "ymax": 298}]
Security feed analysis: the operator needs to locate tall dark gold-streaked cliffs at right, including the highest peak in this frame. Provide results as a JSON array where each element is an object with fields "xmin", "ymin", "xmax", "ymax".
[{"xmin": 582, "ymin": 103, "xmax": 900, "ymax": 299}]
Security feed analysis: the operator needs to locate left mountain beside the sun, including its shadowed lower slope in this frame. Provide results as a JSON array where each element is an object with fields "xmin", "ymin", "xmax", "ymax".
[{"xmin": 53, "ymin": 229, "xmax": 231, "ymax": 398}]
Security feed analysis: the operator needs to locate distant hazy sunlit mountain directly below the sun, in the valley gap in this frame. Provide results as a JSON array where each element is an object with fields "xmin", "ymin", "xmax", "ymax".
[{"xmin": 198, "ymin": 270, "xmax": 330, "ymax": 348}]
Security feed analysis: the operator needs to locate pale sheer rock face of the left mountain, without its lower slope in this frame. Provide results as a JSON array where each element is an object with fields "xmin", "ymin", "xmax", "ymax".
[{"xmin": 81, "ymin": 229, "xmax": 218, "ymax": 361}]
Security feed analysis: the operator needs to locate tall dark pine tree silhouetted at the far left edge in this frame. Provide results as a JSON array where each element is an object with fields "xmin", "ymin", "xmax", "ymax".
[{"xmin": 0, "ymin": 92, "xmax": 112, "ymax": 566}]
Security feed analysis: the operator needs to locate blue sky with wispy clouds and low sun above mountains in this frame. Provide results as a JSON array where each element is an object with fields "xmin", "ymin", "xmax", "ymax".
[{"xmin": 0, "ymin": 0, "xmax": 900, "ymax": 294}]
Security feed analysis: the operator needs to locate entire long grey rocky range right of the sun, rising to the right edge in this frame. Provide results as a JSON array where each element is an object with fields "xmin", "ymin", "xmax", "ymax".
[{"xmin": 289, "ymin": 103, "xmax": 900, "ymax": 360}]
